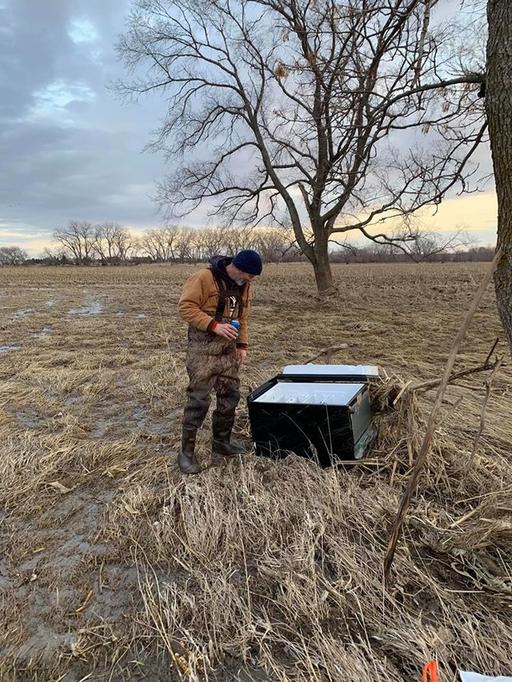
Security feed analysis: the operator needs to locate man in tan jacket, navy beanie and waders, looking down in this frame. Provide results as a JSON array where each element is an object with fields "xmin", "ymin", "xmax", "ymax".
[{"xmin": 178, "ymin": 250, "xmax": 263, "ymax": 474}]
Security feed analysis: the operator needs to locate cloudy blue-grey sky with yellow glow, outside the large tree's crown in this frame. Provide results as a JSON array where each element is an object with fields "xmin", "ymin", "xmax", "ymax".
[{"xmin": 0, "ymin": 0, "xmax": 496, "ymax": 255}]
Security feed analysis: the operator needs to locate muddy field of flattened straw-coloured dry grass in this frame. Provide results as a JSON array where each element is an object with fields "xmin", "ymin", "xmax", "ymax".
[{"xmin": 0, "ymin": 264, "xmax": 512, "ymax": 682}]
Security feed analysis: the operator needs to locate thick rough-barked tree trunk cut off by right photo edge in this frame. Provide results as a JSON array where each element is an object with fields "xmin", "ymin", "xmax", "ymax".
[{"xmin": 486, "ymin": 0, "xmax": 512, "ymax": 352}]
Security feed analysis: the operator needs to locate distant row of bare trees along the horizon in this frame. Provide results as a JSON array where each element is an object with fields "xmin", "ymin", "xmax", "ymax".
[{"xmin": 0, "ymin": 221, "xmax": 494, "ymax": 266}]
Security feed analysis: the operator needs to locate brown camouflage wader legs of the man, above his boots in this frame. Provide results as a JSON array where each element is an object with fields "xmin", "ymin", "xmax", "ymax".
[{"xmin": 183, "ymin": 327, "xmax": 240, "ymax": 442}]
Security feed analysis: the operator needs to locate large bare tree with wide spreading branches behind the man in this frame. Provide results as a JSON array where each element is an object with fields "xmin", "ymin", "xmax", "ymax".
[{"xmin": 118, "ymin": 0, "xmax": 485, "ymax": 294}]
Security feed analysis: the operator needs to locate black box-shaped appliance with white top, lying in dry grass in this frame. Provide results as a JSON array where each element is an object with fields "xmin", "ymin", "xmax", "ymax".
[{"xmin": 247, "ymin": 364, "xmax": 379, "ymax": 467}]
